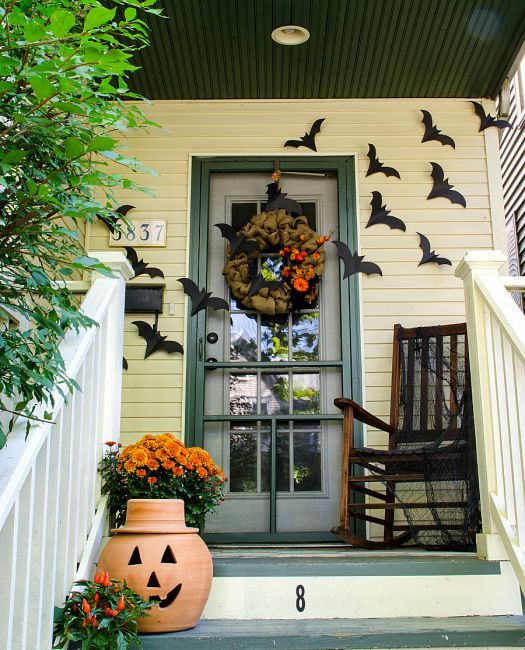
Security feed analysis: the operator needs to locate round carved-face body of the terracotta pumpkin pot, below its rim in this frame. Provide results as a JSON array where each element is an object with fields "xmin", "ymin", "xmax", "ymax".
[{"xmin": 98, "ymin": 534, "xmax": 212, "ymax": 632}]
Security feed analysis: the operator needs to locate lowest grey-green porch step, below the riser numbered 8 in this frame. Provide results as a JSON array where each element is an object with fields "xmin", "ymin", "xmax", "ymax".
[{"xmin": 141, "ymin": 616, "xmax": 525, "ymax": 650}]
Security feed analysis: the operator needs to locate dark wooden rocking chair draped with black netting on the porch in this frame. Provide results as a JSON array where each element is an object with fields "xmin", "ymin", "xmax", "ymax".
[{"xmin": 333, "ymin": 323, "xmax": 479, "ymax": 550}]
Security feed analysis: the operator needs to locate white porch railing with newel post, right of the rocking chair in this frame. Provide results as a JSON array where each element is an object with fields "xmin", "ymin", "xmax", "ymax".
[{"xmin": 456, "ymin": 251, "xmax": 525, "ymax": 593}]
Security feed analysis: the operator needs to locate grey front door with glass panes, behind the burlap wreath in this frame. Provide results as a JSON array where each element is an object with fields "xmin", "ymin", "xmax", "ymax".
[{"xmin": 198, "ymin": 167, "xmax": 348, "ymax": 535}]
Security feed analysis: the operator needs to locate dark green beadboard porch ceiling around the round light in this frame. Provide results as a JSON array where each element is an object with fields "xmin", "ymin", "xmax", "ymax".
[{"xmin": 130, "ymin": 0, "xmax": 525, "ymax": 99}]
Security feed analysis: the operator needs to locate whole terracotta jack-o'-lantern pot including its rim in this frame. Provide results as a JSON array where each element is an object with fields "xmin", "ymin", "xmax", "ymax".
[{"xmin": 98, "ymin": 499, "xmax": 213, "ymax": 632}]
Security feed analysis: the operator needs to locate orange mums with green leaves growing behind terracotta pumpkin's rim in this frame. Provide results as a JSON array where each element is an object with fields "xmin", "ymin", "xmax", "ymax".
[{"xmin": 99, "ymin": 433, "xmax": 226, "ymax": 529}]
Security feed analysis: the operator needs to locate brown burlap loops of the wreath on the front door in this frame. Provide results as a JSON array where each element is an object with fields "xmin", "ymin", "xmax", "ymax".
[{"xmin": 223, "ymin": 210, "xmax": 325, "ymax": 315}]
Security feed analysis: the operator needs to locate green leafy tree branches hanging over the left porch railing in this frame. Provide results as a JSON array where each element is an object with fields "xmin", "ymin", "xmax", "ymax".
[{"xmin": 0, "ymin": 0, "xmax": 159, "ymax": 447}]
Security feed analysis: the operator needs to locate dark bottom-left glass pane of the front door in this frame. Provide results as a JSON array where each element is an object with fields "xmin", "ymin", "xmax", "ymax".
[{"xmin": 229, "ymin": 427, "xmax": 258, "ymax": 492}]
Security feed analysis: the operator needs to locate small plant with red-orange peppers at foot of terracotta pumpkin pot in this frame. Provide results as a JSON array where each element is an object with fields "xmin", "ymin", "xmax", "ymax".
[{"xmin": 53, "ymin": 573, "xmax": 153, "ymax": 650}]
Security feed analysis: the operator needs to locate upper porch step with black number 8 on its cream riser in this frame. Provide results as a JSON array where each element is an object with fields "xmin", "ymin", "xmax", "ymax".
[{"xmin": 203, "ymin": 547, "xmax": 523, "ymax": 616}]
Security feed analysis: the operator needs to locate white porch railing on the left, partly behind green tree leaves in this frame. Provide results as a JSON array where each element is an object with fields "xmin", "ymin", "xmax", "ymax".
[{"xmin": 0, "ymin": 253, "xmax": 132, "ymax": 650}]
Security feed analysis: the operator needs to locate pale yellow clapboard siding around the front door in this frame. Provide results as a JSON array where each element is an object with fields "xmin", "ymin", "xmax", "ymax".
[{"xmin": 88, "ymin": 98, "xmax": 500, "ymax": 438}]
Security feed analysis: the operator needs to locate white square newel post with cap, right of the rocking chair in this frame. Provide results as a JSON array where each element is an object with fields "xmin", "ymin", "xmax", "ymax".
[{"xmin": 455, "ymin": 251, "xmax": 507, "ymax": 560}]
